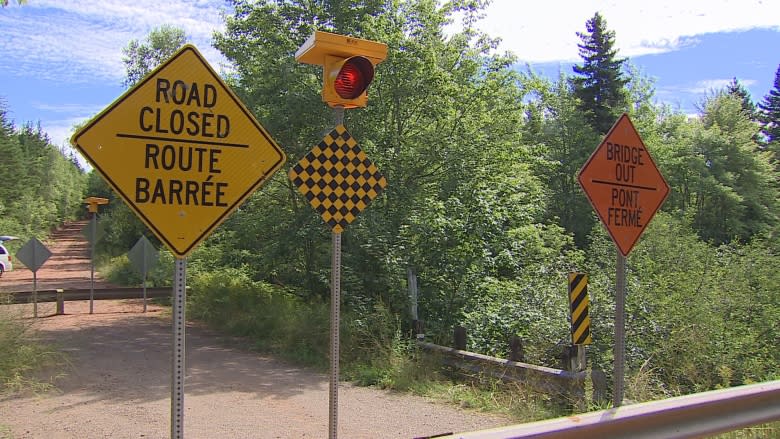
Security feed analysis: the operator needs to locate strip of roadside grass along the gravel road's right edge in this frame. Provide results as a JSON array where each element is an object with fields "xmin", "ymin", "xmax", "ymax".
[{"xmin": 136, "ymin": 271, "xmax": 777, "ymax": 439}]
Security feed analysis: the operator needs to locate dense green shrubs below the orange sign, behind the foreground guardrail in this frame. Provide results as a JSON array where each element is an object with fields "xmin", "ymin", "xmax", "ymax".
[{"xmin": 588, "ymin": 213, "xmax": 780, "ymax": 395}]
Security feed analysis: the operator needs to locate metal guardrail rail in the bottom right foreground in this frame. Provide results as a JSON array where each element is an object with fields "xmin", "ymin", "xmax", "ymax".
[{"xmin": 437, "ymin": 380, "xmax": 780, "ymax": 439}]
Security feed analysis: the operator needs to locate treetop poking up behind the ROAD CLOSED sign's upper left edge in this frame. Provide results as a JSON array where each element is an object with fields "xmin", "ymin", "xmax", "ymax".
[{"xmin": 122, "ymin": 24, "xmax": 188, "ymax": 87}]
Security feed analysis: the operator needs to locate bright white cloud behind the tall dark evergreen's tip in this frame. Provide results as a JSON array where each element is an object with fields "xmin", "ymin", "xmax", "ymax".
[{"xmin": 464, "ymin": 0, "xmax": 780, "ymax": 63}]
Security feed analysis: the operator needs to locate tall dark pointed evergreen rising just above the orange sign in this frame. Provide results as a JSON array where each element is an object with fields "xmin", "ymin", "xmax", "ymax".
[{"xmin": 573, "ymin": 12, "xmax": 628, "ymax": 134}]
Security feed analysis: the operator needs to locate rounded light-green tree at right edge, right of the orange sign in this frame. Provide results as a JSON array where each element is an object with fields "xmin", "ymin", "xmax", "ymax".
[{"xmin": 664, "ymin": 92, "xmax": 778, "ymax": 244}]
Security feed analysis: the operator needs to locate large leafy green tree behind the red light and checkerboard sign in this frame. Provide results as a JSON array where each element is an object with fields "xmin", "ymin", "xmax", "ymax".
[{"xmin": 208, "ymin": 0, "xmax": 572, "ymax": 336}]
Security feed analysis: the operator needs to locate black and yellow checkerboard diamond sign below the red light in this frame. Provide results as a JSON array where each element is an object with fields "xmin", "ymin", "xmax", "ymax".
[{"xmin": 288, "ymin": 125, "xmax": 387, "ymax": 233}]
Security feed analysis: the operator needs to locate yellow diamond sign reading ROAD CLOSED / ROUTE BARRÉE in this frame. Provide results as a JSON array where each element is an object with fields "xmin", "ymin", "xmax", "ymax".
[{"xmin": 71, "ymin": 45, "xmax": 285, "ymax": 257}]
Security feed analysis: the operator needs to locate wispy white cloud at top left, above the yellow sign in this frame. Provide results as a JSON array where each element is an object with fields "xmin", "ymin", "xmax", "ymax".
[{"xmin": 0, "ymin": 0, "xmax": 229, "ymax": 84}]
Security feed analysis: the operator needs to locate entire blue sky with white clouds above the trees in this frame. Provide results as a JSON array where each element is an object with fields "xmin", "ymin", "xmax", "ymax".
[{"xmin": 0, "ymin": 0, "xmax": 780, "ymax": 158}]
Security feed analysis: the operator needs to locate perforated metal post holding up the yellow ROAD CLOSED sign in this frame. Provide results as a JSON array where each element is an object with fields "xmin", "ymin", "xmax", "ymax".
[{"xmin": 171, "ymin": 258, "xmax": 187, "ymax": 439}]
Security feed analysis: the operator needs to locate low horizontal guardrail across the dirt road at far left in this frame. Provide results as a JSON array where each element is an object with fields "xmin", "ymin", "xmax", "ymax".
[{"xmin": 0, "ymin": 287, "xmax": 173, "ymax": 304}]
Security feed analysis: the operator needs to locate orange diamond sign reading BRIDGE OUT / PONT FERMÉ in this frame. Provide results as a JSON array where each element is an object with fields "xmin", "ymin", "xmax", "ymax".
[{"xmin": 578, "ymin": 114, "xmax": 669, "ymax": 256}]
